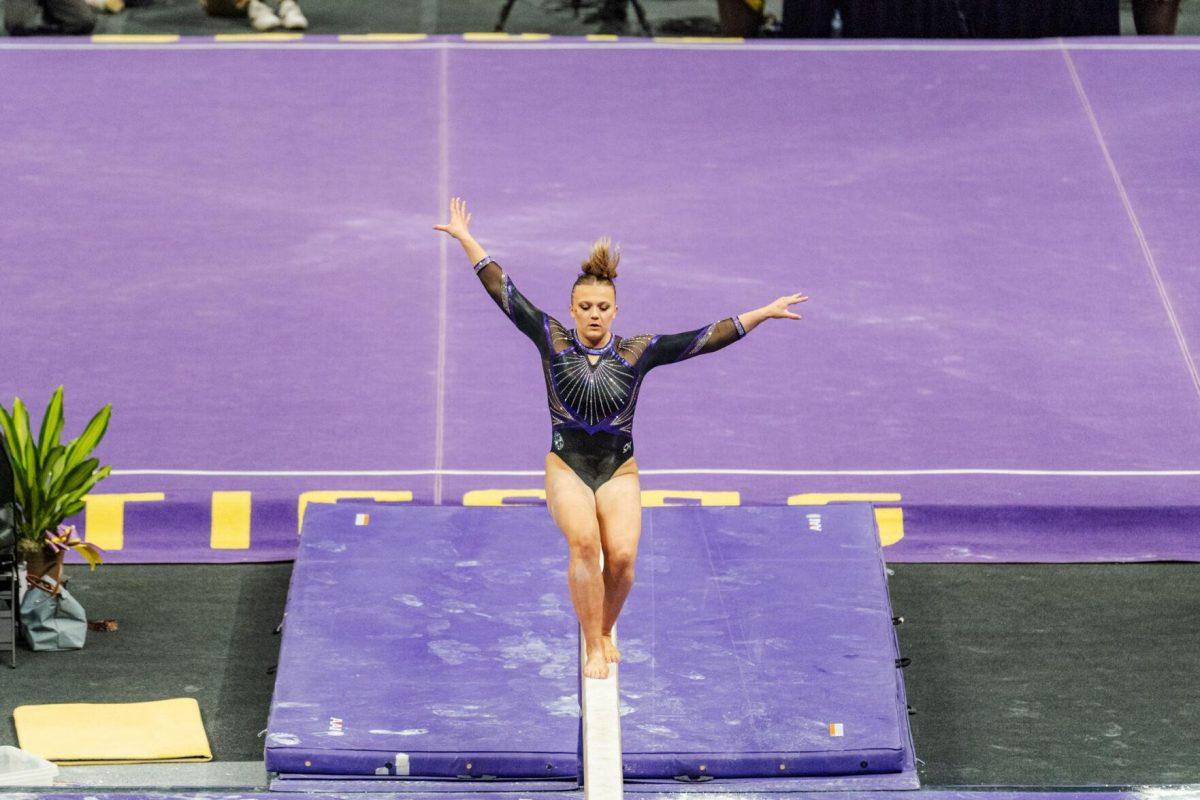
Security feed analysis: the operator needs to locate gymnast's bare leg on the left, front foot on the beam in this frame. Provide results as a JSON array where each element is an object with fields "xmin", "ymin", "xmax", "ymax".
[{"xmin": 546, "ymin": 453, "xmax": 608, "ymax": 678}]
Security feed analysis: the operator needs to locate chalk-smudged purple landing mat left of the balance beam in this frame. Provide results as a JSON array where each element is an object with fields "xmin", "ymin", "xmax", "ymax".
[{"xmin": 266, "ymin": 504, "xmax": 578, "ymax": 786}]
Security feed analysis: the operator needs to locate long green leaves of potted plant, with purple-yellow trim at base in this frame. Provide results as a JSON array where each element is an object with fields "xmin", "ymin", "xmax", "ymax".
[{"xmin": 0, "ymin": 386, "xmax": 113, "ymax": 578}]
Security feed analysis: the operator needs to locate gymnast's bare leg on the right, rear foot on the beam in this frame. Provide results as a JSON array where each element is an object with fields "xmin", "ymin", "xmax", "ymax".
[{"xmin": 596, "ymin": 458, "xmax": 642, "ymax": 661}]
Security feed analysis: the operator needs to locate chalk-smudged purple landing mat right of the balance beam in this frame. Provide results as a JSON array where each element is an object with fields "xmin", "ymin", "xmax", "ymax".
[{"xmin": 618, "ymin": 504, "xmax": 911, "ymax": 781}]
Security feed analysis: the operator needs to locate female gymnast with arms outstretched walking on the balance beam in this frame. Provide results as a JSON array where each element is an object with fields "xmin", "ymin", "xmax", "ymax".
[{"xmin": 433, "ymin": 198, "xmax": 808, "ymax": 679}]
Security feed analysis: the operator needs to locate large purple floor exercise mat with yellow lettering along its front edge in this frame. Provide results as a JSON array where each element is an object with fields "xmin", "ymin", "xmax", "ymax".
[{"xmin": 0, "ymin": 37, "xmax": 1200, "ymax": 563}]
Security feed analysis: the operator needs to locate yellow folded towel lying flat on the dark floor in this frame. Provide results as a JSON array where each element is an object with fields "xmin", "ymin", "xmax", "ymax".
[{"xmin": 12, "ymin": 697, "xmax": 212, "ymax": 765}]
